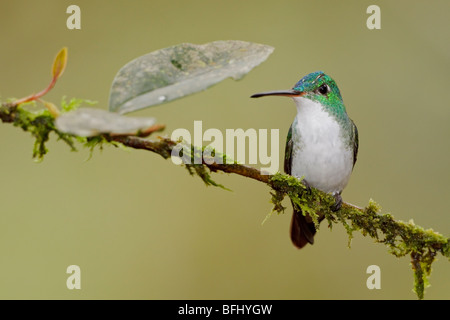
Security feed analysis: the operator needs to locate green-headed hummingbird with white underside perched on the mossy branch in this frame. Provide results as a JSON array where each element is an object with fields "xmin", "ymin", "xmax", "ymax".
[{"xmin": 251, "ymin": 71, "xmax": 359, "ymax": 249}]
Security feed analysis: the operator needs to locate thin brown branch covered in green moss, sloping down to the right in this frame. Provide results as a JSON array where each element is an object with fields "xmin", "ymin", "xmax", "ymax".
[{"xmin": 0, "ymin": 100, "xmax": 450, "ymax": 299}]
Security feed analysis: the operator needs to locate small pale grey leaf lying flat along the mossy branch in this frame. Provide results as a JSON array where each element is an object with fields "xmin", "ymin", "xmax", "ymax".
[{"xmin": 55, "ymin": 108, "xmax": 155, "ymax": 137}]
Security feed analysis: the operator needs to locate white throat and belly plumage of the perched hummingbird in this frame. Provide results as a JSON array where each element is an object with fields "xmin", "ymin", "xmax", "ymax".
[{"xmin": 291, "ymin": 97, "xmax": 353, "ymax": 193}]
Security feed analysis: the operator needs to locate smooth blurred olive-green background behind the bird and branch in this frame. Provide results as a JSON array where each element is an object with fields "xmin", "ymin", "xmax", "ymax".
[{"xmin": 0, "ymin": 0, "xmax": 450, "ymax": 299}]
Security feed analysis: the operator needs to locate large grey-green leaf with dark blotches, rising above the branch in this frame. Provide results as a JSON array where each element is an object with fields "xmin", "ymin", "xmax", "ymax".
[{"xmin": 109, "ymin": 40, "xmax": 274, "ymax": 113}]
